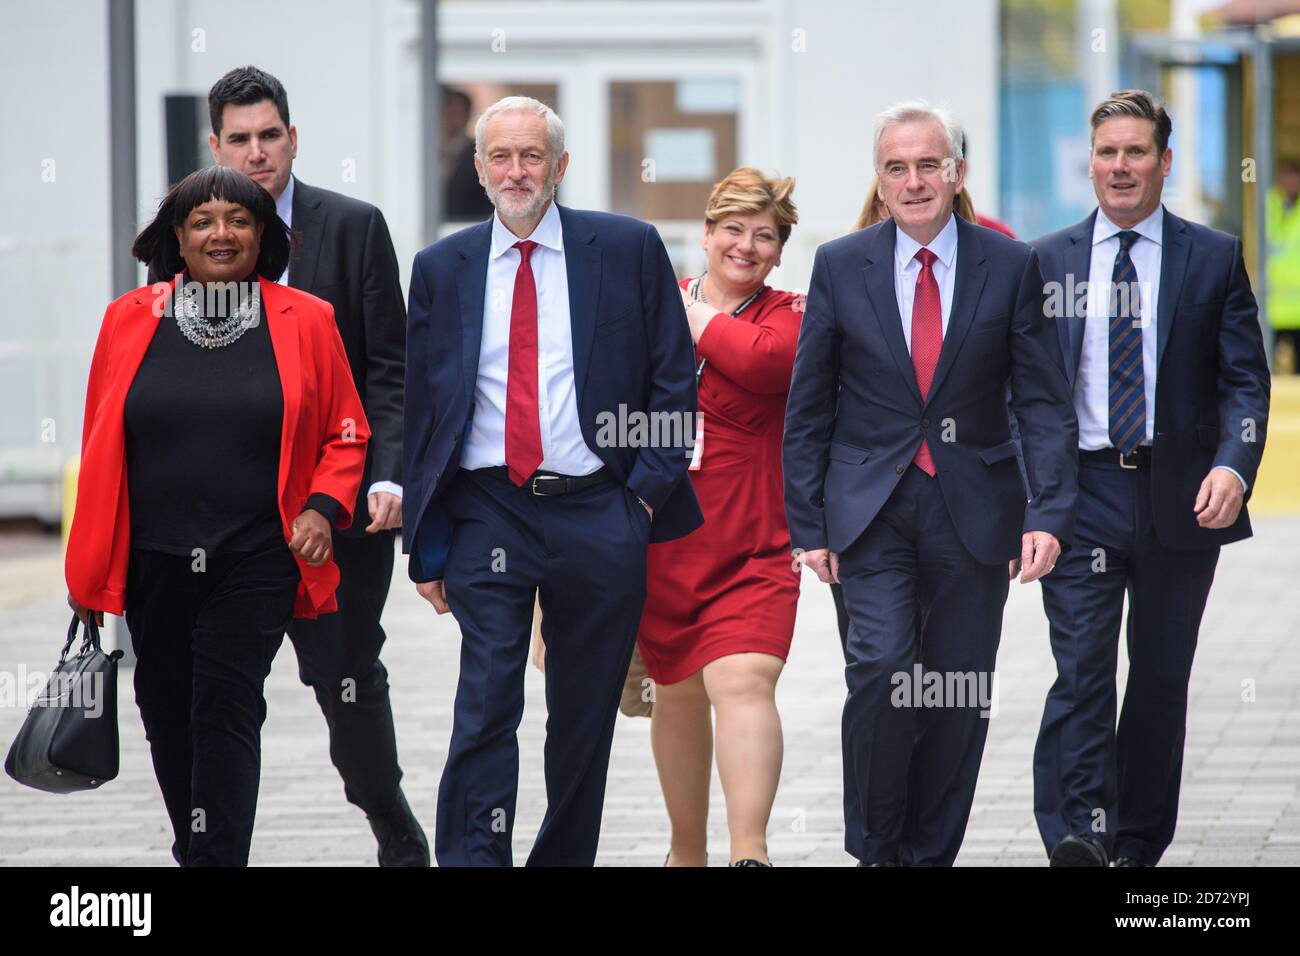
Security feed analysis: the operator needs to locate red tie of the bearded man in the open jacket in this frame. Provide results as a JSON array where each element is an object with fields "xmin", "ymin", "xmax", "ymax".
[{"xmin": 506, "ymin": 239, "xmax": 542, "ymax": 486}]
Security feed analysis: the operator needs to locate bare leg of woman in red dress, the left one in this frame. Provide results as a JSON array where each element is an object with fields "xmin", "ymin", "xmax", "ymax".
[{"xmin": 650, "ymin": 671, "xmax": 714, "ymax": 866}]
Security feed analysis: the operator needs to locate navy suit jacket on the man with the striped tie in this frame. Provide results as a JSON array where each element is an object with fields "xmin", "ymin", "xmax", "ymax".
[{"xmin": 1032, "ymin": 209, "xmax": 1270, "ymax": 548}]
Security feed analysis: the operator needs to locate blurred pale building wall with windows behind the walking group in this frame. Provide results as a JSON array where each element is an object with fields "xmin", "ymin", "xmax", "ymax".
[{"xmin": 0, "ymin": 0, "xmax": 1300, "ymax": 522}]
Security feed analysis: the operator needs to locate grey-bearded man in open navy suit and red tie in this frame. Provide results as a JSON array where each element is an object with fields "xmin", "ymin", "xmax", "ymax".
[{"xmin": 403, "ymin": 96, "xmax": 702, "ymax": 866}]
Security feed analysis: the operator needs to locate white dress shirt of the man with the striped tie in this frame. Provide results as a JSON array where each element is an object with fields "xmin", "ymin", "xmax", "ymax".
[{"xmin": 1074, "ymin": 206, "xmax": 1247, "ymax": 492}]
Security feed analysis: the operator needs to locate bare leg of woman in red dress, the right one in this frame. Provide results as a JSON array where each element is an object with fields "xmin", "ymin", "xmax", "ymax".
[{"xmin": 703, "ymin": 653, "xmax": 785, "ymax": 862}]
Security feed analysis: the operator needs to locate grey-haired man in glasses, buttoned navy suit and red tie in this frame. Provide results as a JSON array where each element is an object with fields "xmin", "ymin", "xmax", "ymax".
[{"xmin": 783, "ymin": 103, "xmax": 1076, "ymax": 866}]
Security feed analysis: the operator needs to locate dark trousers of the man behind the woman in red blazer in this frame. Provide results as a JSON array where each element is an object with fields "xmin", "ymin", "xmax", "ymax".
[{"xmin": 289, "ymin": 528, "xmax": 402, "ymax": 817}]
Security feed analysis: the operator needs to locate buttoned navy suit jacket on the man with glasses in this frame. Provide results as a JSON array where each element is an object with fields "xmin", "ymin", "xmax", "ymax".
[{"xmin": 783, "ymin": 219, "xmax": 1079, "ymax": 564}]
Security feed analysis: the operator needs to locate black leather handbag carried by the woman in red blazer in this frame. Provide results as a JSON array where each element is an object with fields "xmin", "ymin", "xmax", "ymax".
[{"xmin": 4, "ymin": 613, "xmax": 122, "ymax": 793}]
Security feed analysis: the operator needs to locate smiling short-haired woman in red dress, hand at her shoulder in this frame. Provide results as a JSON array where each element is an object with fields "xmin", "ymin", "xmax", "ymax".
[{"xmin": 638, "ymin": 168, "xmax": 802, "ymax": 866}]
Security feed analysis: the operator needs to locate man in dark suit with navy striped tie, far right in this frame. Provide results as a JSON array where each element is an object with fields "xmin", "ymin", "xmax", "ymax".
[{"xmin": 1032, "ymin": 90, "xmax": 1269, "ymax": 866}]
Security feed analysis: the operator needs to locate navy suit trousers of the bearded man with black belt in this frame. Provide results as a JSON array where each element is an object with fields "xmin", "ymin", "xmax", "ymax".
[{"xmin": 434, "ymin": 468, "xmax": 650, "ymax": 866}]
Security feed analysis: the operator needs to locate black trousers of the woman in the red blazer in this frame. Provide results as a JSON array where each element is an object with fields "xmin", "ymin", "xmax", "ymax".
[{"xmin": 126, "ymin": 542, "xmax": 300, "ymax": 866}]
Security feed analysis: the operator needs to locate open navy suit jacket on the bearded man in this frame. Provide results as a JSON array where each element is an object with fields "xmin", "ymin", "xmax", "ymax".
[{"xmin": 402, "ymin": 206, "xmax": 703, "ymax": 581}]
